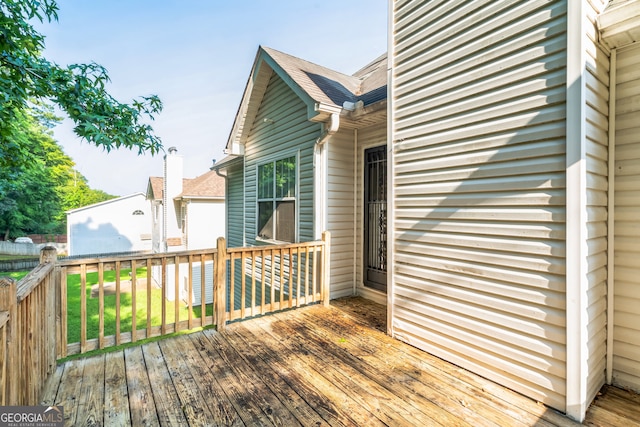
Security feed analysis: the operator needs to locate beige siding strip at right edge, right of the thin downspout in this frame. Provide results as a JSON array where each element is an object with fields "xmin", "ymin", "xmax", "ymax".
[{"xmin": 613, "ymin": 42, "xmax": 640, "ymax": 391}]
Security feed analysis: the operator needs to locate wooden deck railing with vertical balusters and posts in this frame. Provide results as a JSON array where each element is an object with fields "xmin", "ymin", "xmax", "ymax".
[{"xmin": 0, "ymin": 232, "xmax": 330, "ymax": 405}]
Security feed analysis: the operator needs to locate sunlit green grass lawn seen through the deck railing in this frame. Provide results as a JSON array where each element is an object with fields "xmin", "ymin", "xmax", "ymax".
[{"xmin": 67, "ymin": 268, "xmax": 213, "ymax": 343}]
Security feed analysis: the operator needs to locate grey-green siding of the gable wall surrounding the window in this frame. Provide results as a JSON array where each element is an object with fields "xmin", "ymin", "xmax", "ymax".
[{"xmin": 227, "ymin": 73, "xmax": 321, "ymax": 310}]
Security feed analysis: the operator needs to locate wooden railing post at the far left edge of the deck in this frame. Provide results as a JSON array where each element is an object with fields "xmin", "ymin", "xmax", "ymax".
[{"xmin": 0, "ymin": 277, "xmax": 17, "ymax": 406}]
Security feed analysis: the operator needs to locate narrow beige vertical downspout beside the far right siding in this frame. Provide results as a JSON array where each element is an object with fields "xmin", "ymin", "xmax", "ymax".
[{"xmin": 606, "ymin": 49, "xmax": 618, "ymax": 384}]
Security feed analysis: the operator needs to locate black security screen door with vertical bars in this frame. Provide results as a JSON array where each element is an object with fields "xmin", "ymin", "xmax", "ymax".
[{"xmin": 364, "ymin": 146, "xmax": 387, "ymax": 292}]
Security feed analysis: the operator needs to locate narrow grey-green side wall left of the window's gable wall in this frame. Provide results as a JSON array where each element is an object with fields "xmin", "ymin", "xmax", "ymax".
[{"xmin": 226, "ymin": 163, "xmax": 244, "ymax": 248}]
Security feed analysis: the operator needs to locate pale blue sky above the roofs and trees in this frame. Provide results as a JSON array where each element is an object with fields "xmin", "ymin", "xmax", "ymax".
[{"xmin": 36, "ymin": 0, "xmax": 387, "ymax": 196}]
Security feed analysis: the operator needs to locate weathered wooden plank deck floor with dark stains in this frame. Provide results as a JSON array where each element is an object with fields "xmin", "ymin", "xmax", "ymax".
[{"xmin": 43, "ymin": 298, "xmax": 640, "ymax": 426}]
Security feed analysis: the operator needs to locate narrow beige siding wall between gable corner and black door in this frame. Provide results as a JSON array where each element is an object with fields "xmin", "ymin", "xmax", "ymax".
[{"xmin": 327, "ymin": 130, "xmax": 356, "ymax": 298}]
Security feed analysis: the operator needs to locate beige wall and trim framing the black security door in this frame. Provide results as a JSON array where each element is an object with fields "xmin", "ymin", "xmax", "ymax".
[{"xmin": 355, "ymin": 123, "xmax": 387, "ymax": 304}]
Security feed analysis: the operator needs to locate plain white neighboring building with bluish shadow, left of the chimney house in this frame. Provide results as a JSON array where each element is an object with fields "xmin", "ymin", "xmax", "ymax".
[{"xmin": 67, "ymin": 193, "xmax": 151, "ymax": 256}]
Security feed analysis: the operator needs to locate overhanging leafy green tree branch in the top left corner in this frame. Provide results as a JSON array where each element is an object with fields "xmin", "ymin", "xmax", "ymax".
[{"xmin": 0, "ymin": 0, "xmax": 162, "ymax": 171}]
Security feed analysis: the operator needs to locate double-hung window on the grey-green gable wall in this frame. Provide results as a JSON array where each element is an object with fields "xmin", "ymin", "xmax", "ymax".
[{"xmin": 258, "ymin": 156, "xmax": 296, "ymax": 242}]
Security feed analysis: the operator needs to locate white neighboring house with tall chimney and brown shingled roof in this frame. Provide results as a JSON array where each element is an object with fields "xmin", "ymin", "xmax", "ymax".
[{"xmin": 146, "ymin": 147, "xmax": 226, "ymax": 306}]
